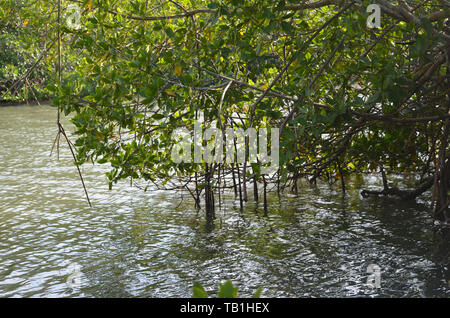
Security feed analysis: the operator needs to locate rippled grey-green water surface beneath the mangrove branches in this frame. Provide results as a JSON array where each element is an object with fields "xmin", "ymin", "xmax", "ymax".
[{"xmin": 0, "ymin": 107, "xmax": 450, "ymax": 297}]
